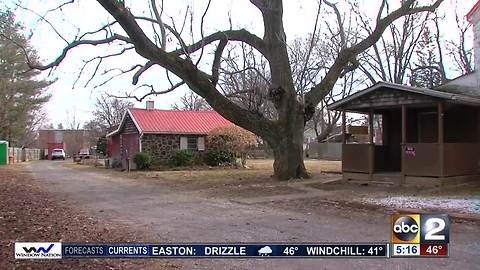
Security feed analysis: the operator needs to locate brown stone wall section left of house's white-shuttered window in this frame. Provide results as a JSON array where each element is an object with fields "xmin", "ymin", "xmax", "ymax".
[{"xmin": 142, "ymin": 134, "xmax": 180, "ymax": 164}]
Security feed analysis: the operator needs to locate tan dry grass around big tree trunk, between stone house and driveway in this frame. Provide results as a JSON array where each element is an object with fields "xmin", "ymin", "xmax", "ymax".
[{"xmin": 66, "ymin": 159, "xmax": 341, "ymax": 197}]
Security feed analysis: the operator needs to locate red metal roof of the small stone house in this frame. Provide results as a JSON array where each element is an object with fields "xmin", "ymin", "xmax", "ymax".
[{"xmin": 128, "ymin": 108, "xmax": 233, "ymax": 134}]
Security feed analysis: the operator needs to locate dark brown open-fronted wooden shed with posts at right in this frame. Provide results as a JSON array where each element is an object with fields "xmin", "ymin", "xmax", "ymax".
[{"xmin": 329, "ymin": 82, "xmax": 480, "ymax": 185}]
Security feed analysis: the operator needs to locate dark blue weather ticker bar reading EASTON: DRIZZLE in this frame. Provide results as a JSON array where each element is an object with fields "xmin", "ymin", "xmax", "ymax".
[{"xmin": 61, "ymin": 243, "xmax": 390, "ymax": 259}]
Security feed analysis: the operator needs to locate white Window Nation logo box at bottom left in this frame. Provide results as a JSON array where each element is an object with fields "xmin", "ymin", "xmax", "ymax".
[{"xmin": 15, "ymin": 242, "xmax": 62, "ymax": 259}]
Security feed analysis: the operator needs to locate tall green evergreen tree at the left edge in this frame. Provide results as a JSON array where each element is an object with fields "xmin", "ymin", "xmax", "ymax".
[{"xmin": 0, "ymin": 10, "xmax": 52, "ymax": 147}]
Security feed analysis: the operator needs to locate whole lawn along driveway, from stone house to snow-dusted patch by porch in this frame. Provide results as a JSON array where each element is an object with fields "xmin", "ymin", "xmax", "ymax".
[{"xmin": 66, "ymin": 159, "xmax": 480, "ymax": 218}]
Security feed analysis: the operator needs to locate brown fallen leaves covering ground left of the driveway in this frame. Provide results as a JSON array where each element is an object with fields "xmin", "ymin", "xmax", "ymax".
[{"xmin": 0, "ymin": 165, "xmax": 178, "ymax": 270}]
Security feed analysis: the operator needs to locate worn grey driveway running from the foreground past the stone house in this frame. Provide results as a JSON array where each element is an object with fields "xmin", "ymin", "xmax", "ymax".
[{"xmin": 28, "ymin": 161, "xmax": 480, "ymax": 269}]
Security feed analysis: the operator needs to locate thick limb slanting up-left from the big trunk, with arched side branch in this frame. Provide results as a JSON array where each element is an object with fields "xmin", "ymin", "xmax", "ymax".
[{"xmin": 98, "ymin": 0, "xmax": 277, "ymax": 135}]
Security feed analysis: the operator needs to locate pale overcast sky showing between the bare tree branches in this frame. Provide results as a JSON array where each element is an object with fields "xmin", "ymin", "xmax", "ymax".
[{"xmin": 0, "ymin": 0, "xmax": 476, "ymax": 126}]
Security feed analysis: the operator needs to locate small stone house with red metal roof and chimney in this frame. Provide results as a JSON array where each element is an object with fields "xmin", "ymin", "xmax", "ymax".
[{"xmin": 107, "ymin": 101, "xmax": 233, "ymax": 165}]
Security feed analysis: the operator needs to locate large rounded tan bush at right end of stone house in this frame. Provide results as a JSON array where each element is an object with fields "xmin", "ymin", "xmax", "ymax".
[{"xmin": 206, "ymin": 125, "xmax": 256, "ymax": 167}]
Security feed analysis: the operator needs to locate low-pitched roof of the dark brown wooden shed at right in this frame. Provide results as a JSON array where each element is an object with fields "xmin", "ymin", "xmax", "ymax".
[{"xmin": 328, "ymin": 82, "xmax": 480, "ymax": 110}]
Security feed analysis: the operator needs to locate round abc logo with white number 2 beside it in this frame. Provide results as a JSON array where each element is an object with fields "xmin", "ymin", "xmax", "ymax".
[{"xmin": 392, "ymin": 214, "xmax": 450, "ymax": 244}]
